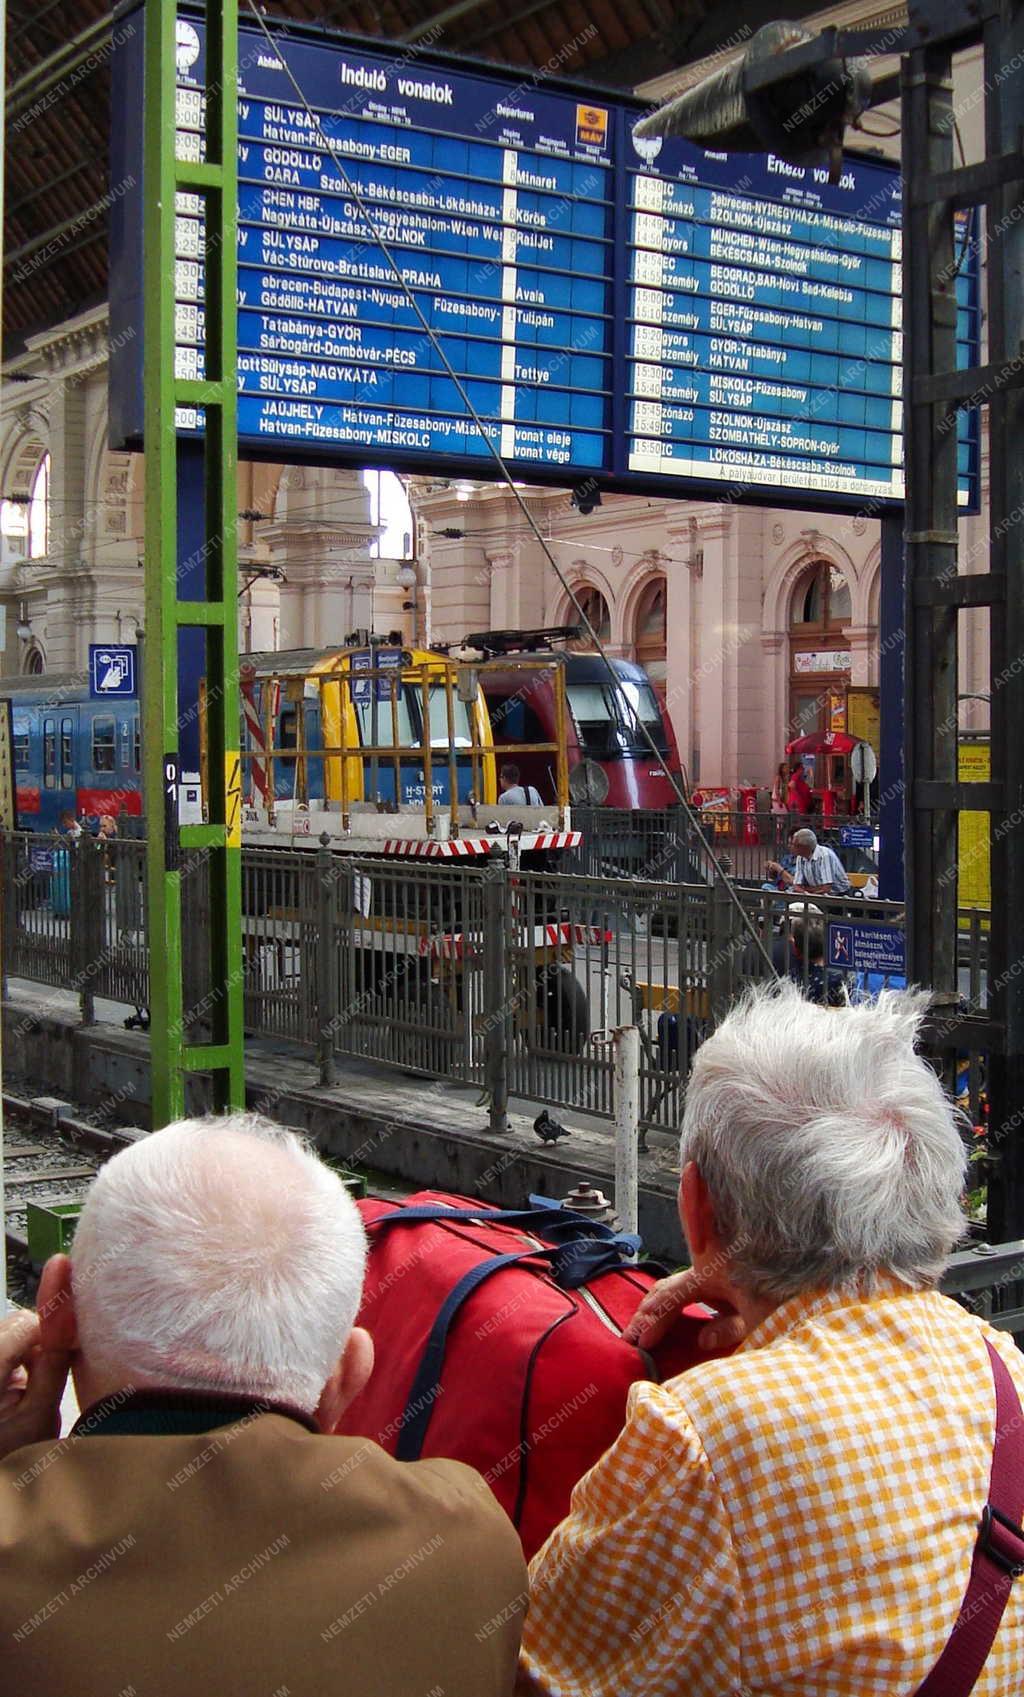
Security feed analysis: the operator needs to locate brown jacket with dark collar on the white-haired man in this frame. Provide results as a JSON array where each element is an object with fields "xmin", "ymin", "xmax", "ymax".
[{"xmin": 0, "ymin": 1392, "xmax": 526, "ymax": 1697}]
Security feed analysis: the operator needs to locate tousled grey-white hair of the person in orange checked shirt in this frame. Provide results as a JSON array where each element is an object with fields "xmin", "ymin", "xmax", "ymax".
[{"xmin": 681, "ymin": 983, "xmax": 966, "ymax": 1300}]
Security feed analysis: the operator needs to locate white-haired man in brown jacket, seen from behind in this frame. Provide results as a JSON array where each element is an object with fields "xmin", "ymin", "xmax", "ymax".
[{"xmin": 0, "ymin": 1113, "xmax": 525, "ymax": 1697}]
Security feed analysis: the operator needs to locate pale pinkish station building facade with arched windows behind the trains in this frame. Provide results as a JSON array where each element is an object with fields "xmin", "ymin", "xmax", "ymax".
[{"xmin": 0, "ymin": 0, "xmax": 988, "ymax": 786}]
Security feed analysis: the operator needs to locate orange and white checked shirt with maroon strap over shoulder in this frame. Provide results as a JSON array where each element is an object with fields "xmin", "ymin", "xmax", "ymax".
[{"xmin": 520, "ymin": 1280, "xmax": 1024, "ymax": 1697}]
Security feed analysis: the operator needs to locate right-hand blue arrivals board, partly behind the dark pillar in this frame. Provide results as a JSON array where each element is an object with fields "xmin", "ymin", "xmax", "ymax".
[{"xmin": 627, "ymin": 139, "xmax": 976, "ymax": 506}]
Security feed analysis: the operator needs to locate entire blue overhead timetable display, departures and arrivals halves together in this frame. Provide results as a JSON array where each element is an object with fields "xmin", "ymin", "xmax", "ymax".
[{"xmin": 110, "ymin": 12, "xmax": 978, "ymax": 511}]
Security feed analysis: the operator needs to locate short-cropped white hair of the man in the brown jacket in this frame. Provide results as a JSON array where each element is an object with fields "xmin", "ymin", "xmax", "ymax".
[{"xmin": 71, "ymin": 1113, "xmax": 367, "ymax": 1412}]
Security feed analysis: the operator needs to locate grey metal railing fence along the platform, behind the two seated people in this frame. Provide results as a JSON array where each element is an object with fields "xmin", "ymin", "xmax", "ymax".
[{"xmin": 0, "ymin": 815, "xmax": 987, "ymax": 1137}]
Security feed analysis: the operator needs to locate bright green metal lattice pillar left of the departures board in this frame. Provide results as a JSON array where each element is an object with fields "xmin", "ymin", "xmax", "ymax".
[{"xmin": 143, "ymin": 0, "xmax": 245, "ymax": 1127}]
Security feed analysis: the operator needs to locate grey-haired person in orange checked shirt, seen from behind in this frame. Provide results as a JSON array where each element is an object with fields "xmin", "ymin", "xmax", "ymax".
[{"xmin": 521, "ymin": 984, "xmax": 1024, "ymax": 1697}]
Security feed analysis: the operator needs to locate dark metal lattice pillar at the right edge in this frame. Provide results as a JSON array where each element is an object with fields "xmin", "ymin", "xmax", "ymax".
[{"xmin": 902, "ymin": 0, "xmax": 1024, "ymax": 1242}]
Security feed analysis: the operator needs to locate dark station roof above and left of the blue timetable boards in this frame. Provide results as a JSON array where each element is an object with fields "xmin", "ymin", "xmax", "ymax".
[{"xmin": 3, "ymin": 0, "xmax": 842, "ymax": 355}]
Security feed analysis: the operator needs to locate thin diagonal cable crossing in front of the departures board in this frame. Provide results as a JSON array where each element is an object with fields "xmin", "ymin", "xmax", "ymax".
[{"xmin": 248, "ymin": 0, "xmax": 776, "ymax": 974}]
